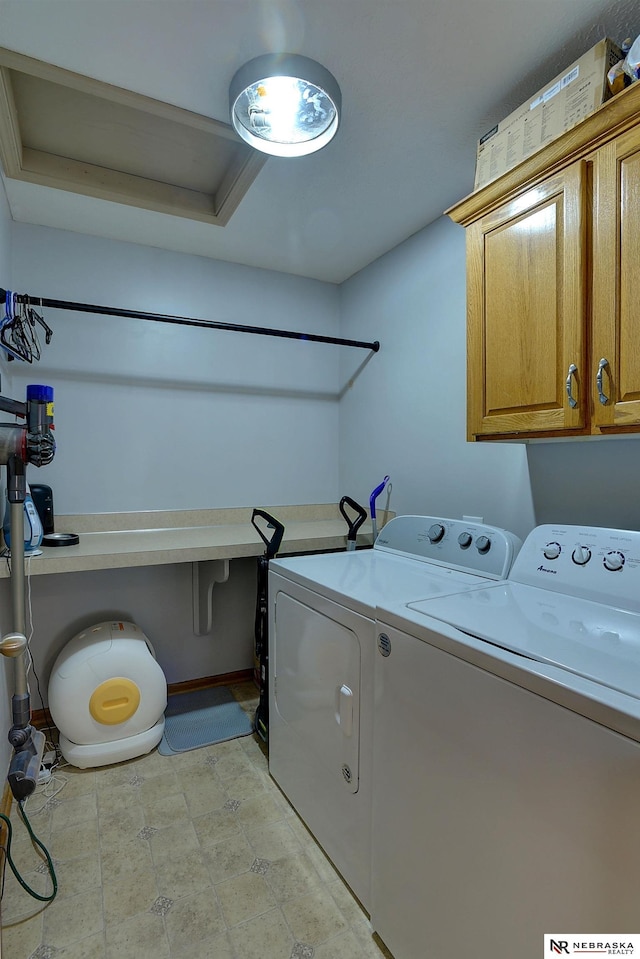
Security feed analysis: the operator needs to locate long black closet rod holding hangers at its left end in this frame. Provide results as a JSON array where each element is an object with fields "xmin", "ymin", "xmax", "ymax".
[{"xmin": 0, "ymin": 289, "xmax": 380, "ymax": 353}]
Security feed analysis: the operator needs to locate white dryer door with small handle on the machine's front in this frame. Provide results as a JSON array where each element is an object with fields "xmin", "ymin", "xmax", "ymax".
[{"xmin": 273, "ymin": 591, "xmax": 361, "ymax": 793}]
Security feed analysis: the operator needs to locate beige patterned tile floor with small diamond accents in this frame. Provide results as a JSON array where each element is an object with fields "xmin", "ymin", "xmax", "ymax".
[{"xmin": 2, "ymin": 683, "xmax": 390, "ymax": 959}]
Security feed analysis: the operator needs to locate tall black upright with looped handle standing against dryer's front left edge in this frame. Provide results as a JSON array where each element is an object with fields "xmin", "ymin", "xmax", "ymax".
[{"xmin": 251, "ymin": 509, "xmax": 284, "ymax": 743}]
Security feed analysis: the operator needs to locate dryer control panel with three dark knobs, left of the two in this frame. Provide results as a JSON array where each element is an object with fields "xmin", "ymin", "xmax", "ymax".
[{"xmin": 374, "ymin": 516, "xmax": 522, "ymax": 579}]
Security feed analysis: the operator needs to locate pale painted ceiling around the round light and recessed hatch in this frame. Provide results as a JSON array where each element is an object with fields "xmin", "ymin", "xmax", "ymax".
[{"xmin": 0, "ymin": 0, "xmax": 640, "ymax": 283}]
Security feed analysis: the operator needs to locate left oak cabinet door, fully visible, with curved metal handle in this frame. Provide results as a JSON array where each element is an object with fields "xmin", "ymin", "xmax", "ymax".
[{"xmin": 467, "ymin": 162, "xmax": 589, "ymax": 439}]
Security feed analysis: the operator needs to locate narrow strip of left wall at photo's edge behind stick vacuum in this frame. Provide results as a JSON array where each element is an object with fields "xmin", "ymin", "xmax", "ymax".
[{"xmin": 0, "ymin": 176, "xmax": 13, "ymax": 780}]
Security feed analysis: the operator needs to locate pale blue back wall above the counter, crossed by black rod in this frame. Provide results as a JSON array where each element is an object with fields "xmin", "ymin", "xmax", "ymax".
[{"xmin": 13, "ymin": 224, "xmax": 340, "ymax": 513}]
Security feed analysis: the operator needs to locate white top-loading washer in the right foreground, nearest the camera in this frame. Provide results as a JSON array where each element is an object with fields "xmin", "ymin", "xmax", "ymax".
[{"xmin": 371, "ymin": 526, "xmax": 640, "ymax": 959}]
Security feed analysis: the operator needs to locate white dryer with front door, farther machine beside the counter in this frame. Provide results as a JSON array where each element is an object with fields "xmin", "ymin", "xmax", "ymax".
[{"xmin": 269, "ymin": 516, "xmax": 520, "ymax": 911}]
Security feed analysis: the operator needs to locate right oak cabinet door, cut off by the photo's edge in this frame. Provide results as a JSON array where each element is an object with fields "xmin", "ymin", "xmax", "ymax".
[{"xmin": 591, "ymin": 129, "xmax": 640, "ymax": 432}]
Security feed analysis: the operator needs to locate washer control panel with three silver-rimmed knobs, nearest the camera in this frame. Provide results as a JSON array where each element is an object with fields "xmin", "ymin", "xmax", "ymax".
[{"xmin": 509, "ymin": 525, "xmax": 640, "ymax": 609}]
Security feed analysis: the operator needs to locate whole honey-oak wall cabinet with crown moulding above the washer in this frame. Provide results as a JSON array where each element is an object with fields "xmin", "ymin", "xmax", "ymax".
[{"xmin": 447, "ymin": 83, "xmax": 640, "ymax": 440}]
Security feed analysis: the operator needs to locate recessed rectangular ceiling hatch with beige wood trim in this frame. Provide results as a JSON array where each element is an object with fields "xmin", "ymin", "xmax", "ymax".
[{"xmin": 0, "ymin": 47, "xmax": 266, "ymax": 226}]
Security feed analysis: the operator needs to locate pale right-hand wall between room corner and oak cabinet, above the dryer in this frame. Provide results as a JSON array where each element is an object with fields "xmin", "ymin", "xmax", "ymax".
[{"xmin": 340, "ymin": 218, "xmax": 535, "ymax": 536}]
